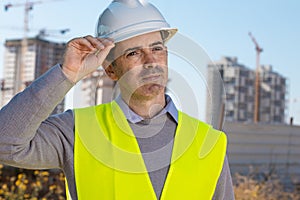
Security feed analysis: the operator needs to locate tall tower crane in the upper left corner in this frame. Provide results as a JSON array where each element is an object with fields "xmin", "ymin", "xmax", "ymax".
[{"xmin": 4, "ymin": 0, "xmax": 61, "ymax": 94}]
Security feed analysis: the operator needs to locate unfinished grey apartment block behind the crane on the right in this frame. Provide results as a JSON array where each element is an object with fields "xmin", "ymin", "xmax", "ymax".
[{"xmin": 207, "ymin": 57, "xmax": 287, "ymax": 124}]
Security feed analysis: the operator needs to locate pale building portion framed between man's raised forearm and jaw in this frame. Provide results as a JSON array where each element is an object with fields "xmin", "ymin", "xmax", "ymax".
[{"xmin": 80, "ymin": 69, "xmax": 117, "ymax": 107}]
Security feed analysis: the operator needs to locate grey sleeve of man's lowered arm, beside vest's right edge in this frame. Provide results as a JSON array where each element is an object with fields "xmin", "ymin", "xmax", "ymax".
[{"xmin": 213, "ymin": 156, "xmax": 235, "ymax": 200}]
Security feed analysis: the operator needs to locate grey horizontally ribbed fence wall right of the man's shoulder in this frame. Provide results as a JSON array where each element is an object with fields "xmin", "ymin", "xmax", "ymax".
[{"xmin": 223, "ymin": 122, "xmax": 300, "ymax": 184}]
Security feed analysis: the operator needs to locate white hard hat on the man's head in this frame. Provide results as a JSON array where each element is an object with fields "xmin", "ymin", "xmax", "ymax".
[{"xmin": 96, "ymin": 0, "xmax": 177, "ymax": 42}]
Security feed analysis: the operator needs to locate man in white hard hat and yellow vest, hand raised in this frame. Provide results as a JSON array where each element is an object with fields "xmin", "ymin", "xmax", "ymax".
[{"xmin": 0, "ymin": 0, "xmax": 234, "ymax": 199}]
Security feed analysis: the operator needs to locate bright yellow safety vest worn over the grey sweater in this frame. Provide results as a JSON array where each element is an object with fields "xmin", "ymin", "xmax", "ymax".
[{"xmin": 69, "ymin": 101, "xmax": 227, "ymax": 200}]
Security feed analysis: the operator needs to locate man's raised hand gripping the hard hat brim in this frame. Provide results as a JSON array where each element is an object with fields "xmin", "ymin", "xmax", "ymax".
[{"xmin": 62, "ymin": 35, "xmax": 115, "ymax": 83}]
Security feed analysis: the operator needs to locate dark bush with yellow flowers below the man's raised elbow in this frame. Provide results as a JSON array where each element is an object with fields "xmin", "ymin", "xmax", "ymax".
[{"xmin": 0, "ymin": 165, "xmax": 66, "ymax": 200}]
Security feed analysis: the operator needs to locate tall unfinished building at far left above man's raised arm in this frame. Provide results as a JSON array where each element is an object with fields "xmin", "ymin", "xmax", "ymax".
[{"xmin": 0, "ymin": 37, "xmax": 65, "ymax": 113}]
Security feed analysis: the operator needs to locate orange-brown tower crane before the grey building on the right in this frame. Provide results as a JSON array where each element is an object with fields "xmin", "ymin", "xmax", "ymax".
[{"xmin": 249, "ymin": 32, "xmax": 263, "ymax": 123}]
